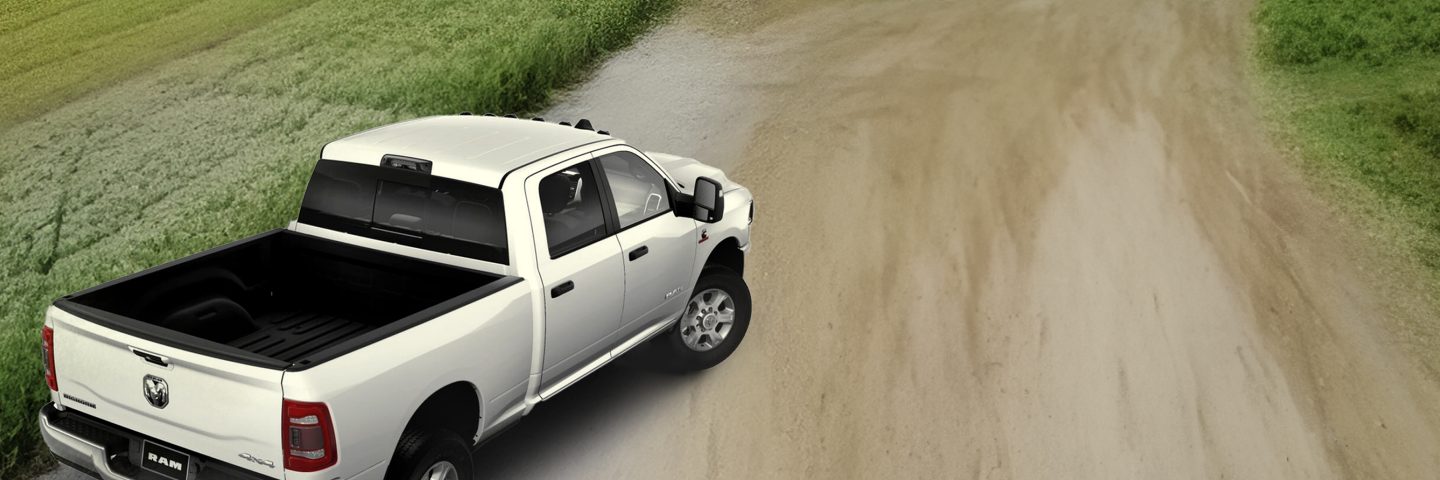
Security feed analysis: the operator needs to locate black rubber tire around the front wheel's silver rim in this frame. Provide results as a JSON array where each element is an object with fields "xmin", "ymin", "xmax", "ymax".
[{"xmin": 649, "ymin": 267, "xmax": 750, "ymax": 373}]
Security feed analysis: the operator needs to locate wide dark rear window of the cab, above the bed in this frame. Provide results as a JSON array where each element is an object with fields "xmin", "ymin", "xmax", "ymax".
[{"xmin": 300, "ymin": 160, "xmax": 510, "ymax": 264}]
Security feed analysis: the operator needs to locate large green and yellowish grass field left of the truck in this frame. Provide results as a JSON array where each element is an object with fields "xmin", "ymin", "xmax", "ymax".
[{"xmin": 0, "ymin": 0, "xmax": 672, "ymax": 479}]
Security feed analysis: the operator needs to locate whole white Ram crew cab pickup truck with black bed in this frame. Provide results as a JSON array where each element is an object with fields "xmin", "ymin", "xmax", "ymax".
[{"xmin": 40, "ymin": 115, "xmax": 755, "ymax": 480}]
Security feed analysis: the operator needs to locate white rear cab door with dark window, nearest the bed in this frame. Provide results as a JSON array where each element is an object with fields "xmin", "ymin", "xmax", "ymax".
[{"xmin": 526, "ymin": 154, "xmax": 625, "ymax": 388}]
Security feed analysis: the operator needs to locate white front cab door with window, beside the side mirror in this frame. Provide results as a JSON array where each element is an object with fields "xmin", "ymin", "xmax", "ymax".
[{"xmin": 595, "ymin": 147, "xmax": 698, "ymax": 340}]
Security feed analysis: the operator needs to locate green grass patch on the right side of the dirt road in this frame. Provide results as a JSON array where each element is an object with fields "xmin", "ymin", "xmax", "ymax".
[{"xmin": 1256, "ymin": 0, "xmax": 1440, "ymax": 367}]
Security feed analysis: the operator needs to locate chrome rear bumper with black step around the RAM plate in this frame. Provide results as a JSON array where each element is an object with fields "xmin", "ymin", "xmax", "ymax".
[{"xmin": 40, "ymin": 404, "xmax": 271, "ymax": 480}]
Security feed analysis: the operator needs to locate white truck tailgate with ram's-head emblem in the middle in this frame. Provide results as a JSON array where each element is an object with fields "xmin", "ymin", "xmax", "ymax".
[{"xmin": 46, "ymin": 307, "xmax": 284, "ymax": 479}]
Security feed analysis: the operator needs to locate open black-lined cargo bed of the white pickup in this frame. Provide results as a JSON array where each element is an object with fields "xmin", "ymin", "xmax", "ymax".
[{"xmin": 56, "ymin": 231, "xmax": 518, "ymax": 369}]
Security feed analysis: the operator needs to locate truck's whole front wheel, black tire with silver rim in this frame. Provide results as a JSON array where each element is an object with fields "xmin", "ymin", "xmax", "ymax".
[{"xmin": 655, "ymin": 267, "xmax": 750, "ymax": 372}]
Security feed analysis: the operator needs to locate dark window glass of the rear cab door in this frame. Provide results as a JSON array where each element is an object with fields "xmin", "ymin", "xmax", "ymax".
[{"xmin": 540, "ymin": 161, "xmax": 606, "ymax": 258}]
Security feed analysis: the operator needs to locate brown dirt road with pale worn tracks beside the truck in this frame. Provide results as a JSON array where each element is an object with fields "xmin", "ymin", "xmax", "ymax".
[{"xmin": 39, "ymin": 0, "xmax": 1440, "ymax": 479}]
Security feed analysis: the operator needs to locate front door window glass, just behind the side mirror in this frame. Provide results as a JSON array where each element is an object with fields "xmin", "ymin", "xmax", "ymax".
[{"xmin": 600, "ymin": 151, "xmax": 670, "ymax": 228}]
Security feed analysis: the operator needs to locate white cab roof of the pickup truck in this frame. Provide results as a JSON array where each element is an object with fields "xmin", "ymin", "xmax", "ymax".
[{"xmin": 320, "ymin": 115, "xmax": 615, "ymax": 187}]
